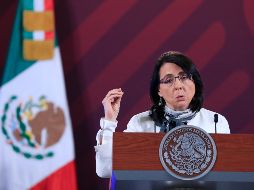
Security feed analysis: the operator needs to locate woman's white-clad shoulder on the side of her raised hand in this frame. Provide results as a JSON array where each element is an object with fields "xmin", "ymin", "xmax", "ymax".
[{"xmin": 125, "ymin": 110, "xmax": 154, "ymax": 132}]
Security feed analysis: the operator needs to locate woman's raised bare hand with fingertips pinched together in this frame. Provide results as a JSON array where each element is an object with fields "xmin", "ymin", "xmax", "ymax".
[{"xmin": 102, "ymin": 88, "xmax": 123, "ymax": 121}]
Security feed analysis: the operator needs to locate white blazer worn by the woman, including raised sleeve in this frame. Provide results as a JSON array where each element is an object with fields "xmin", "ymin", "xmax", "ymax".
[{"xmin": 94, "ymin": 108, "xmax": 230, "ymax": 178}]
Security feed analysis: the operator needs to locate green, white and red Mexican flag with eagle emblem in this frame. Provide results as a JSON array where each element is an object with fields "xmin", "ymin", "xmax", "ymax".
[{"xmin": 0, "ymin": 0, "xmax": 77, "ymax": 190}]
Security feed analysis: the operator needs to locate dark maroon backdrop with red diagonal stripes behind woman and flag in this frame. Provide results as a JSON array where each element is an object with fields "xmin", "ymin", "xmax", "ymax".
[{"xmin": 0, "ymin": 0, "xmax": 254, "ymax": 189}]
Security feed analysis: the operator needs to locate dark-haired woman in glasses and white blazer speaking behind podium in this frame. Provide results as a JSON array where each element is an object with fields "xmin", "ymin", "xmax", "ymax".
[{"xmin": 95, "ymin": 51, "xmax": 230, "ymax": 177}]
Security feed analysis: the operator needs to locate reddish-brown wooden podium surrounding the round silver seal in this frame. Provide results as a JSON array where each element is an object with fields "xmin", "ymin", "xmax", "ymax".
[{"xmin": 111, "ymin": 132, "xmax": 254, "ymax": 190}]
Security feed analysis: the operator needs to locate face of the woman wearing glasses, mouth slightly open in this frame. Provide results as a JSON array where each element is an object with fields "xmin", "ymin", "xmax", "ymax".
[{"xmin": 158, "ymin": 63, "xmax": 195, "ymax": 111}]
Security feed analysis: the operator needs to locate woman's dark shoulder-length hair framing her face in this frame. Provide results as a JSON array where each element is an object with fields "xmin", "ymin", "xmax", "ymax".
[{"xmin": 150, "ymin": 51, "xmax": 203, "ymax": 123}]
